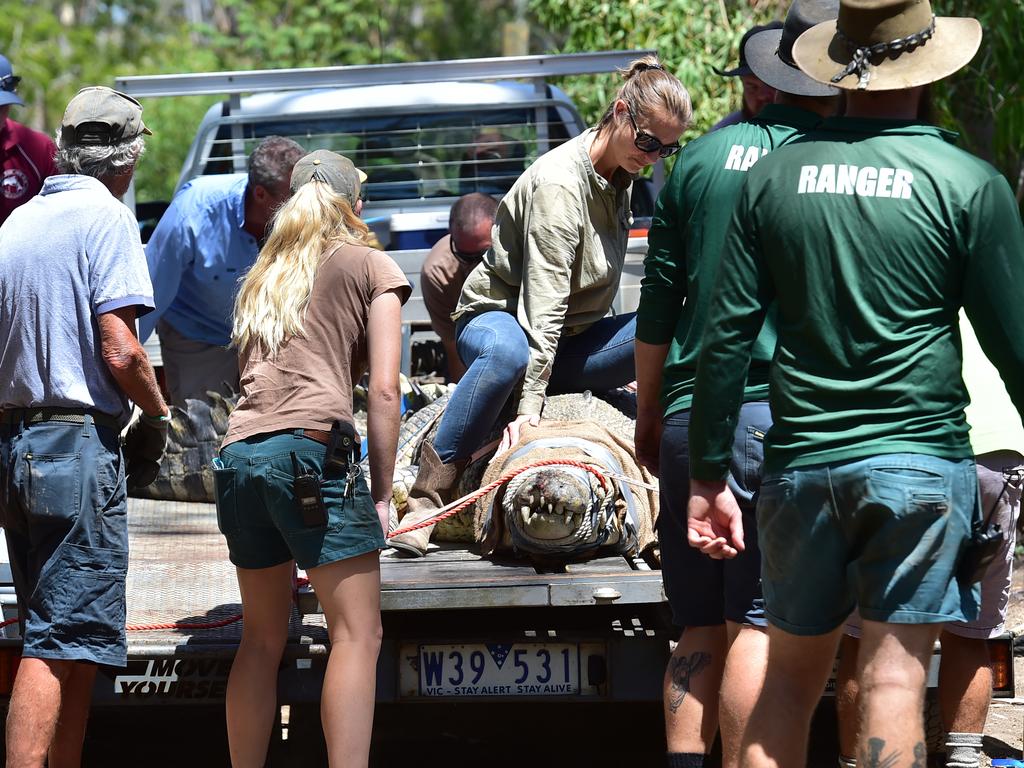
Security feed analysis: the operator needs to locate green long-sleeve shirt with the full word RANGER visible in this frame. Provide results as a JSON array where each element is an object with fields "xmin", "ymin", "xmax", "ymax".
[{"xmin": 690, "ymin": 118, "xmax": 1024, "ymax": 480}]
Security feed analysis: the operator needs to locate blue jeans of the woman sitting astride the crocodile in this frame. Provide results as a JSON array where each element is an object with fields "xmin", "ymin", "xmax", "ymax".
[{"xmin": 434, "ymin": 310, "xmax": 637, "ymax": 464}]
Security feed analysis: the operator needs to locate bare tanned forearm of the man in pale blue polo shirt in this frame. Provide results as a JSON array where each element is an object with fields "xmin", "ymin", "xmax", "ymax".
[{"xmin": 97, "ymin": 306, "xmax": 168, "ymax": 416}]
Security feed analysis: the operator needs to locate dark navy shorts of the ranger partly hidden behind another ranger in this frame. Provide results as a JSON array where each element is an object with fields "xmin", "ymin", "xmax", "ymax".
[{"xmin": 657, "ymin": 402, "xmax": 771, "ymax": 627}]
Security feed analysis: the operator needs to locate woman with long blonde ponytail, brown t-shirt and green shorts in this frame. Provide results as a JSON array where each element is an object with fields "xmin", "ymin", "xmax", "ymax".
[{"xmin": 216, "ymin": 151, "xmax": 410, "ymax": 768}]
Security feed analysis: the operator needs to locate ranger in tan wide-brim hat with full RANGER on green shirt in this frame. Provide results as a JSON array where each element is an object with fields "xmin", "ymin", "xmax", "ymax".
[{"xmin": 688, "ymin": 0, "xmax": 1024, "ymax": 765}]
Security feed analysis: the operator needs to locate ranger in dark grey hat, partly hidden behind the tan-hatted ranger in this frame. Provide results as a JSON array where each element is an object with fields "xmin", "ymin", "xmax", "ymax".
[{"xmin": 636, "ymin": 0, "xmax": 839, "ymax": 766}]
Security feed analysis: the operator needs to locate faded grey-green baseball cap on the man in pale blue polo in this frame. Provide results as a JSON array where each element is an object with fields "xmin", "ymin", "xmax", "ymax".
[{"xmin": 60, "ymin": 85, "xmax": 153, "ymax": 146}]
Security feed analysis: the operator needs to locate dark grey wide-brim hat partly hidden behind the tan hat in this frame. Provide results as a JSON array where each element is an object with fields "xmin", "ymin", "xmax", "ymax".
[{"xmin": 743, "ymin": 0, "xmax": 839, "ymax": 96}]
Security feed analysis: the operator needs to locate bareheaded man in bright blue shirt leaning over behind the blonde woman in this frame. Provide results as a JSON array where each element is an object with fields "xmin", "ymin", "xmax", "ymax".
[{"xmin": 139, "ymin": 136, "xmax": 306, "ymax": 407}]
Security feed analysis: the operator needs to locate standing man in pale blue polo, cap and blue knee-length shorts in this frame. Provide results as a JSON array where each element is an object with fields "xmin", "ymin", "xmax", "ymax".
[{"xmin": 0, "ymin": 87, "xmax": 170, "ymax": 768}]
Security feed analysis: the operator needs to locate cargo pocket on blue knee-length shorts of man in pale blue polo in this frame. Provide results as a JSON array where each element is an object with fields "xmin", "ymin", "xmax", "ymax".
[{"xmin": 49, "ymin": 544, "xmax": 128, "ymax": 640}]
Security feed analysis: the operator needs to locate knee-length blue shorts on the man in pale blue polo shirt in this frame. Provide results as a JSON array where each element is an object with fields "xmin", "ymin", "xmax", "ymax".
[{"xmin": 0, "ymin": 419, "xmax": 128, "ymax": 667}]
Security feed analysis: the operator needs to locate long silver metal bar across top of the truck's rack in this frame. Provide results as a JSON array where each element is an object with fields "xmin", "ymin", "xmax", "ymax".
[{"xmin": 115, "ymin": 50, "xmax": 654, "ymax": 97}]
